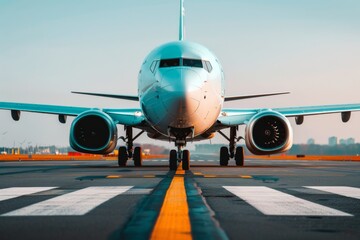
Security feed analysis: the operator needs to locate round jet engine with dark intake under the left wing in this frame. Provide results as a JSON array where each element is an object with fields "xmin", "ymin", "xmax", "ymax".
[{"xmin": 70, "ymin": 110, "xmax": 117, "ymax": 154}]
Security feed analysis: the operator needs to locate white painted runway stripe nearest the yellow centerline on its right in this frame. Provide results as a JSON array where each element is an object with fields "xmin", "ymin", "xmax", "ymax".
[{"xmin": 224, "ymin": 186, "xmax": 353, "ymax": 216}]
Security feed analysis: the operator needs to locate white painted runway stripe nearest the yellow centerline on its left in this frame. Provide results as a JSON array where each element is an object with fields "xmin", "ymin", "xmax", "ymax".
[{"xmin": 2, "ymin": 186, "xmax": 131, "ymax": 216}]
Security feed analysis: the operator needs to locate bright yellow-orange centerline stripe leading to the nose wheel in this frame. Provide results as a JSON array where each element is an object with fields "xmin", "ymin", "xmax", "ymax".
[{"xmin": 151, "ymin": 164, "xmax": 192, "ymax": 240}]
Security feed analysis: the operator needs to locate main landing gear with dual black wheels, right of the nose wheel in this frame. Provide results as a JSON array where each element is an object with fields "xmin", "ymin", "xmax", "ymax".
[{"xmin": 218, "ymin": 127, "xmax": 245, "ymax": 166}]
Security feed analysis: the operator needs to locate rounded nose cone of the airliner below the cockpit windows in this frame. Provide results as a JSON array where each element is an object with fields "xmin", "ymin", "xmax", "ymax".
[{"xmin": 159, "ymin": 69, "xmax": 203, "ymax": 119}]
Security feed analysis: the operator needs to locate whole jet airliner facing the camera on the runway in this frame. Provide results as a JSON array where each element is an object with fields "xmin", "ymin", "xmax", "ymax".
[{"xmin": 0, "ymin": 0, "xmax": 360, "ymax": 170}]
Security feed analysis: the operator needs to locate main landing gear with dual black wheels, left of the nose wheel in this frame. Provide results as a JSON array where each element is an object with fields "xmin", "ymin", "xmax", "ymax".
[{"xmin": 118, "ymin": 127, "xmax": 144, "ymax": 167}]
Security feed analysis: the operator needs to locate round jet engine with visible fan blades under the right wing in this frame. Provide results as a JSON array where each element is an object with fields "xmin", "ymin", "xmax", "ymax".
[{"xmin": 245, "ymin": 110, "xmax": 293, "ymax": 155}]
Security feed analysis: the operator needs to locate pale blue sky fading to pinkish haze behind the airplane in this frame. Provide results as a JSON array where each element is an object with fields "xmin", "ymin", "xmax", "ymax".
[{"xmin": 0, "ymin": 0, "xmax": 360, "ymax": 147}]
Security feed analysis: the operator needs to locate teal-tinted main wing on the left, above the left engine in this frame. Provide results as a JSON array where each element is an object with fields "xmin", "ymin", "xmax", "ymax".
[{"xmin": 0, "ymin": 102, "xmax": 145, "ymax": 126}]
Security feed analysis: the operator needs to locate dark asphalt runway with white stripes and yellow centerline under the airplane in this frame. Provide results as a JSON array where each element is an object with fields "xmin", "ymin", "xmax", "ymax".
[{"xmin": 0, "ymin": 155, "xmax": 360, "ymax": 239}]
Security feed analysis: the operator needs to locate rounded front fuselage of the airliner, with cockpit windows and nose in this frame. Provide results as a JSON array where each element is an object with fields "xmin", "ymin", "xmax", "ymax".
[{"xmin": 138, "ymin": 41, "xmax": 225, "ymax": 137}]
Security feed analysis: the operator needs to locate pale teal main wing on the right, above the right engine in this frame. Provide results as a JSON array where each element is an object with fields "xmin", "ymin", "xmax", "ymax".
[{"xmin": 218, "ymin": 104, "xmax": 360, "ymax": 126}]
